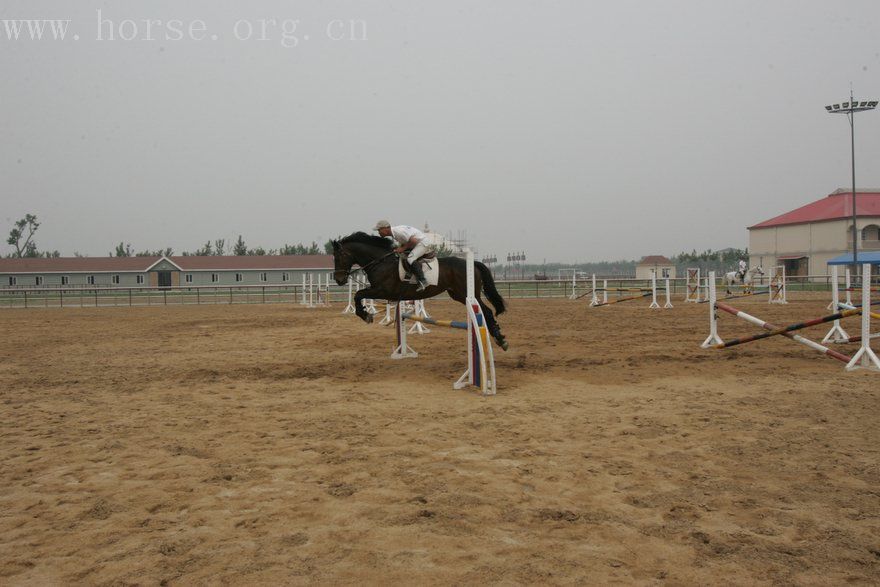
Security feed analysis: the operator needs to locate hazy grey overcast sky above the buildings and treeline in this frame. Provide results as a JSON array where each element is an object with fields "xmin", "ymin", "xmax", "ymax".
[{"xmin": 0, "ymin": 0, "xmax": 880, "ymax": 262}]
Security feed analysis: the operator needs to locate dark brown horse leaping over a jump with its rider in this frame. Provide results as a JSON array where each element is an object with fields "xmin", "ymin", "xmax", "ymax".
[{"xmin": 332, "ymin": 232, "xmax": 509, "ymax": 350}]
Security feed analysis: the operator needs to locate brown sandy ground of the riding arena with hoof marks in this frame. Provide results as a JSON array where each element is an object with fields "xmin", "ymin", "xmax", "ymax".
[{"xmin": 0, "ymin": 294, "xmax": 880, "ymax": 585}]
